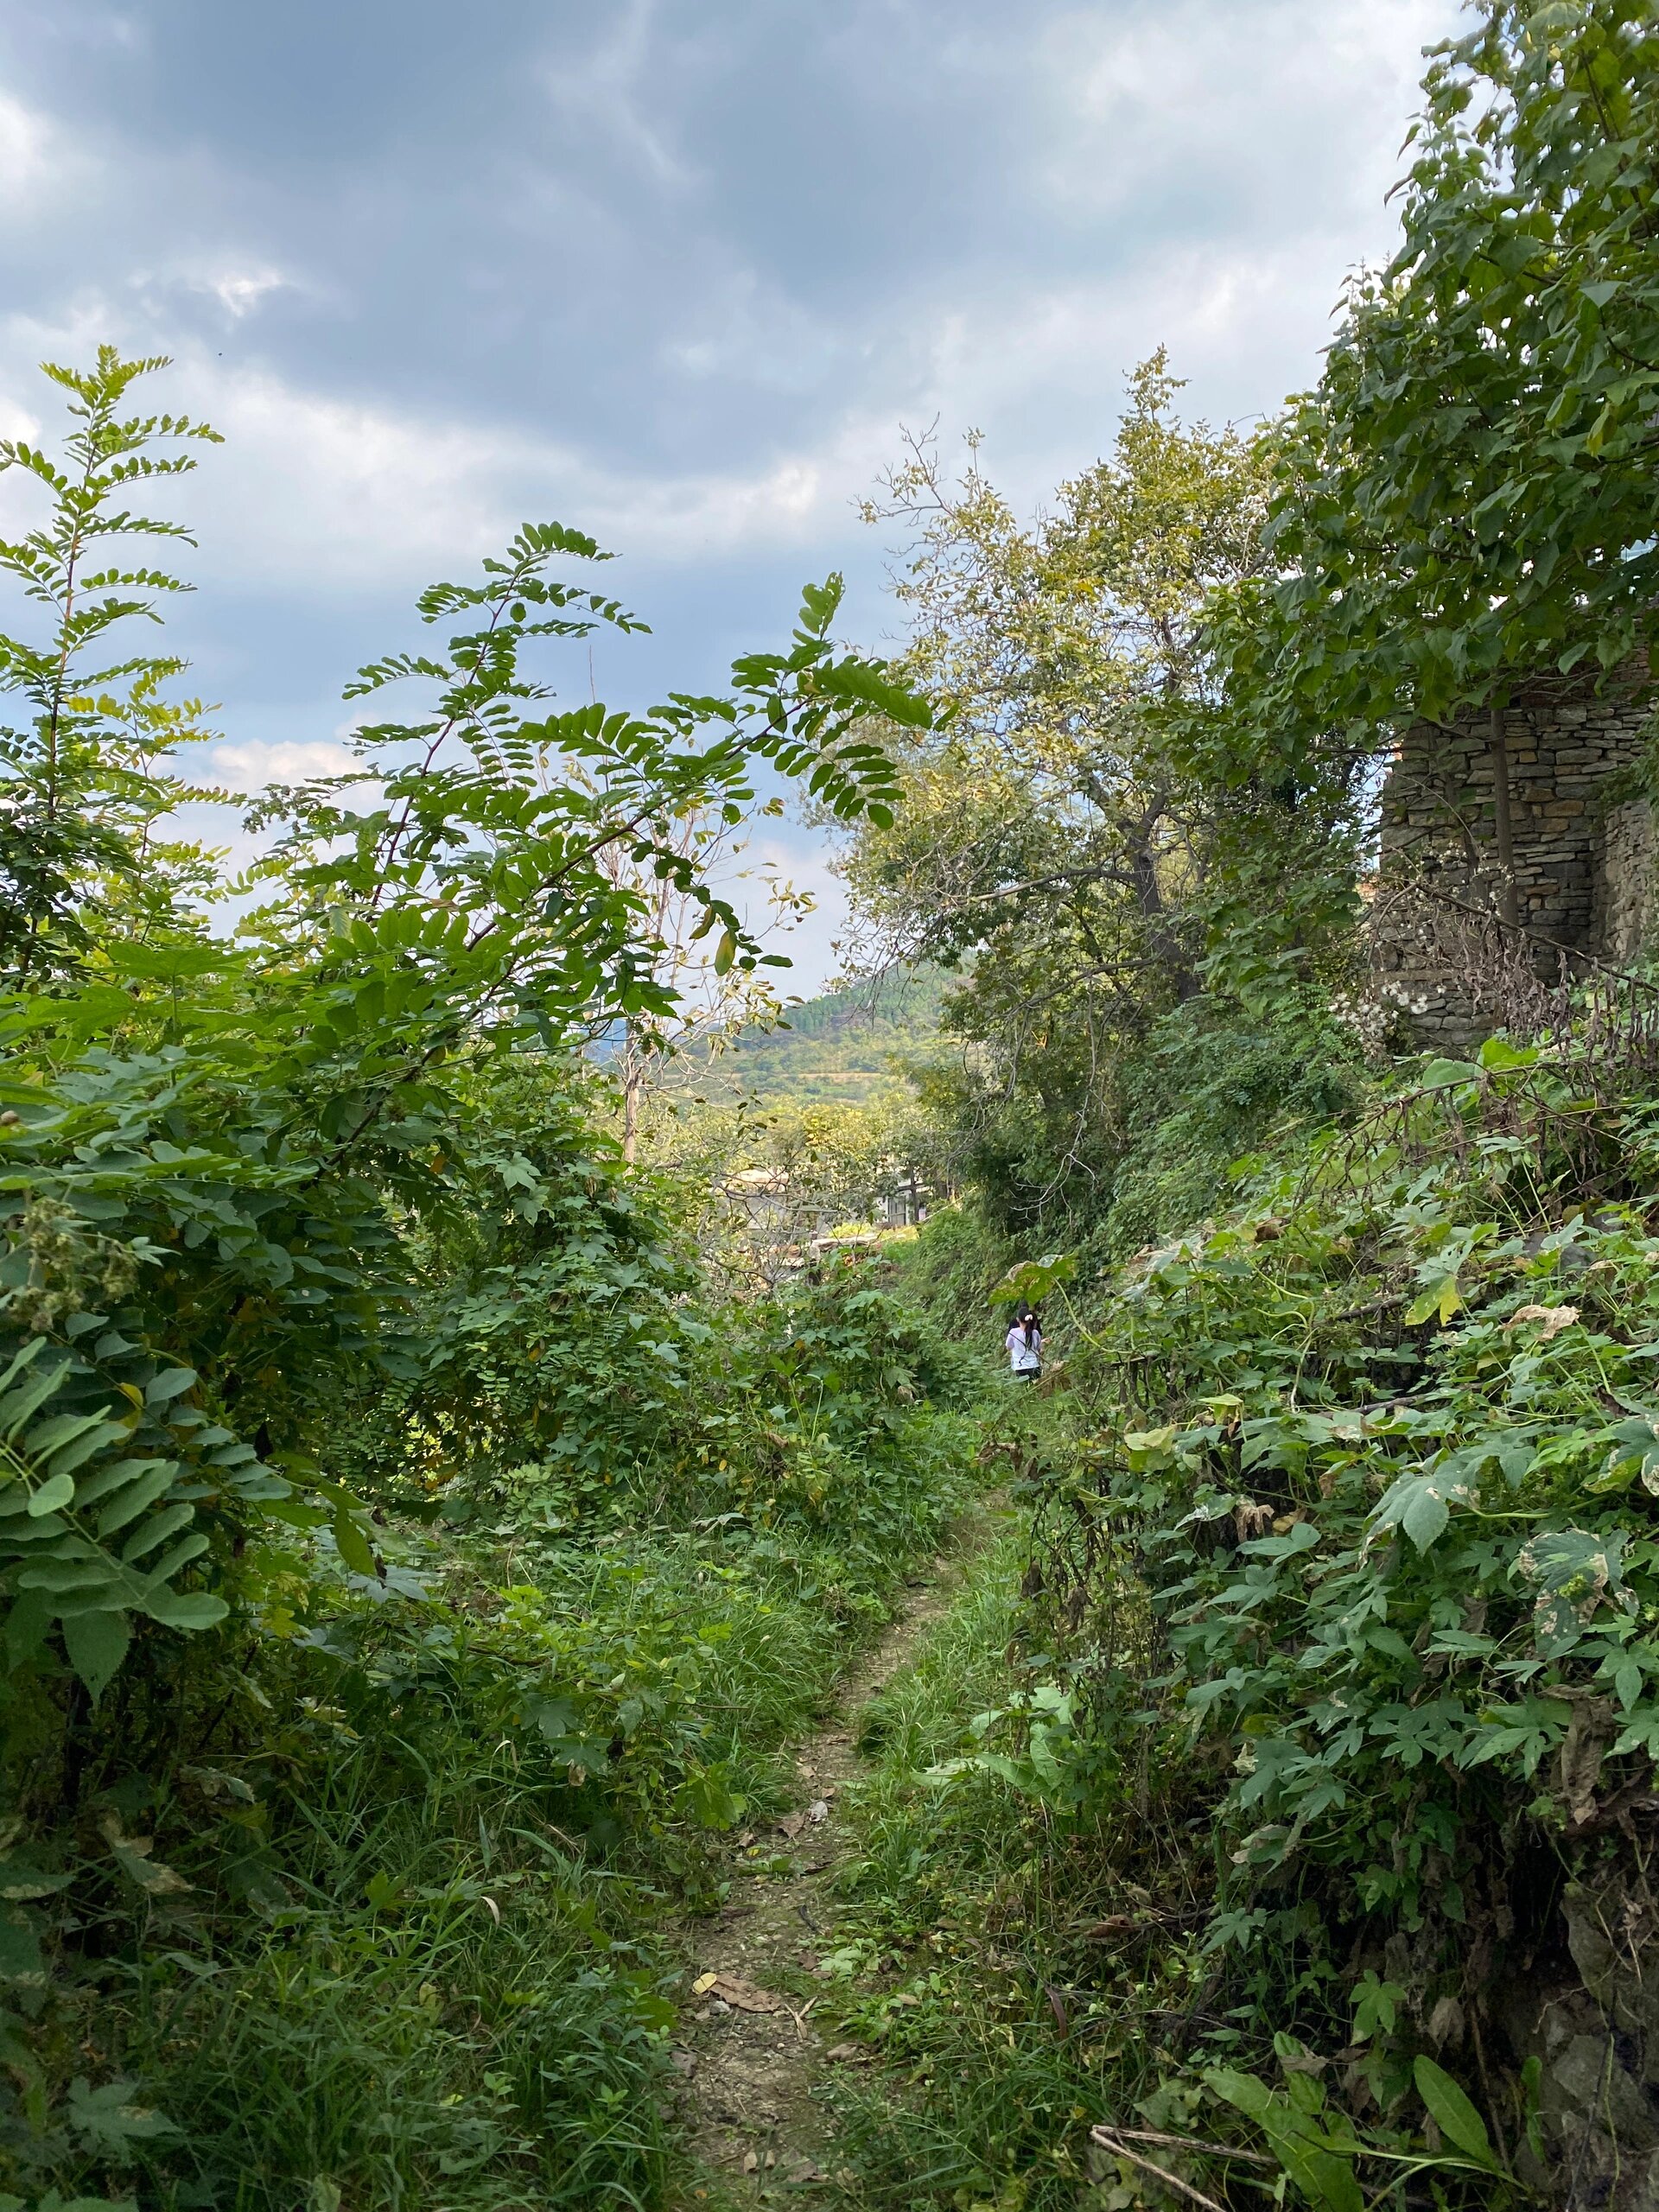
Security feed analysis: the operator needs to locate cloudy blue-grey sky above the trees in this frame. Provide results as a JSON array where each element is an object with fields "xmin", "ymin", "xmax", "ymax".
[{"xmin": 0, "ymin": 0, "xmax": 1458, "ymax": 991}]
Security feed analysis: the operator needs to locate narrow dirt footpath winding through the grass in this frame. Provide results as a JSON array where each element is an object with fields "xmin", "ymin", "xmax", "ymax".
[{"xmin": 675, "ymin": 1533, "xmax": 995, "ymax": 2208}]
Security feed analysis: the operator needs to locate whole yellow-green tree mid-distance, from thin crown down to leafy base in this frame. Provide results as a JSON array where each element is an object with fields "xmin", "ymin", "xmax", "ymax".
[{"xmin": 849, "ymin": 352, "xmax": 1300, "ymax": 1238}]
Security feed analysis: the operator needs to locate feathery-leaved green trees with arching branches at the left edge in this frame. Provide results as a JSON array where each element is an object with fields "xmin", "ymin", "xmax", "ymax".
[{"xmin": 0, "ymin": 354, "xmax": 927, "ymax": 1694}]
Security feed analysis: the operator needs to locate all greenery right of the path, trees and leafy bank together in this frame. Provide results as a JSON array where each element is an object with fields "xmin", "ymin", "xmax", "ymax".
[{"xmin": 787, "ymin": 13, "xmax": 1659, "ymax": 2212}]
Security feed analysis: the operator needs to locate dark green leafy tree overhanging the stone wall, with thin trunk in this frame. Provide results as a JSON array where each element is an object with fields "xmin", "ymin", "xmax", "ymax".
[{"xmin": 1217, "ymin": 0, "xmax": 1659, "ymax": 920}]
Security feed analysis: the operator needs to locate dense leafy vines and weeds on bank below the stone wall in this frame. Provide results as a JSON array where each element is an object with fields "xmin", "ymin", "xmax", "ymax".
[{"xmin": 814, "ymin": 1039, "xmax": 1659, "ymax": 2205}]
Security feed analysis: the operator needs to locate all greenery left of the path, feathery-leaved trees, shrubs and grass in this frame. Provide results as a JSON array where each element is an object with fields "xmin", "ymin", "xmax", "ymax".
[{"xmin": 0, "ymin": 352, "xmax": 986, "ymax": 2212}]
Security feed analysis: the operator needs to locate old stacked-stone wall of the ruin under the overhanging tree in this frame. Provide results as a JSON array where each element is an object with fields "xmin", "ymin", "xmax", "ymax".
[{"xmin": 1374, "ymin": 668, "xmax": 1655, "ymax": 1044}]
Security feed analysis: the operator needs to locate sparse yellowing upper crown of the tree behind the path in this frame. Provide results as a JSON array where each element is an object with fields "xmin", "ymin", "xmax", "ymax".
[{"xmin": 854, "ymin": 352, "xmax": 1265, "ymax": 1008}]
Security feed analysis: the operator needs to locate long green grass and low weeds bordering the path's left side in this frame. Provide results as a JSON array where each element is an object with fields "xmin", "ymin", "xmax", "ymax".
[{"xmin": 0, "ymin": 1283, "xmax": 1000, "ymax": 2212}]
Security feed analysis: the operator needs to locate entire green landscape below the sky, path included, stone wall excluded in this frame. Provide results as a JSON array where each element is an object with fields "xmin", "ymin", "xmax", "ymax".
[{"xmin": 0, "ymin": 0, "xmax": 1659, "ymax": 2212}]
